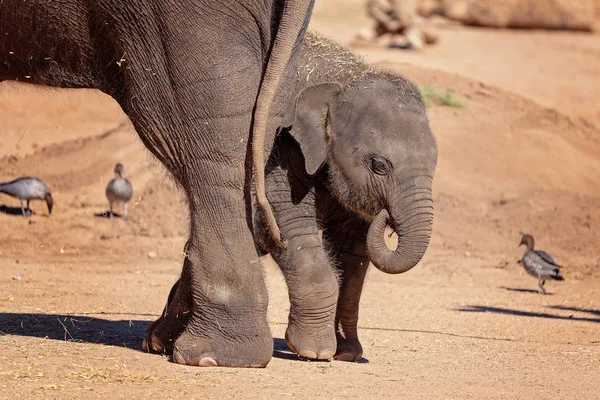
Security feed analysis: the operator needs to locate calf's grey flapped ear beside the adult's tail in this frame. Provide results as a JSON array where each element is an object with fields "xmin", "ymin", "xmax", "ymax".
[{"xmin": 282, "ymin": 82, "xmax": 342, "ymax": 175}]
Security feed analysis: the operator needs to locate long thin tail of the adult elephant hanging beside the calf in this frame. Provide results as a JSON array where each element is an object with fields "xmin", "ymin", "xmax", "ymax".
[{"xmin": 252, "ymin": 0, "xmax": 313, "ymax": 248}]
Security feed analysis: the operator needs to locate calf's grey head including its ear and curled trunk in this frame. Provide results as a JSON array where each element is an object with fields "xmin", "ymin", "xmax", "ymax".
[{"xmin": 284, "ymin": 74, "xmax": 437, "ymax": 273}]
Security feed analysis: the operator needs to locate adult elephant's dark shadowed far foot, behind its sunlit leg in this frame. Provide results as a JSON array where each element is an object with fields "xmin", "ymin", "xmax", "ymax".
[{"xmin": 142, "ymin": 281, "xmax": 191, "ymax": 355}]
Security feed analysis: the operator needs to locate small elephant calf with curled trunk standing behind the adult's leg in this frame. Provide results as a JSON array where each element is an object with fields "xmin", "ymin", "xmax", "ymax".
[{"xmin": 255, "ymin": 33, "xmax": 437, "ymax": 361}]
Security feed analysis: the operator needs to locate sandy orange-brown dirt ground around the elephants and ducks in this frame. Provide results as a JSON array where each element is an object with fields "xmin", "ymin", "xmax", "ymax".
[{"xmin": 0, "ymin": 0, "xmax": 600, "ymax": 399}]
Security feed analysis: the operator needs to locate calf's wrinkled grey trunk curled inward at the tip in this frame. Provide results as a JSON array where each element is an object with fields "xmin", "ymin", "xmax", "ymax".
[{"xmin": 367, "ymin": 183, "xmax": 433, "ymax": 274}]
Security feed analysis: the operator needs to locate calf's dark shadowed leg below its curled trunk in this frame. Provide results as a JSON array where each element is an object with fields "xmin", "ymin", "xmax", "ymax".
[{"xmin": 324, "ymin": 211, "xmax": 369, "ymax": 361}]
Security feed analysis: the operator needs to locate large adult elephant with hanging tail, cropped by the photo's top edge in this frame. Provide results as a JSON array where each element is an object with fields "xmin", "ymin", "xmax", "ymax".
[{"xmin": 0, "ymin": 0, "xmax": 314, "ymax": 366}]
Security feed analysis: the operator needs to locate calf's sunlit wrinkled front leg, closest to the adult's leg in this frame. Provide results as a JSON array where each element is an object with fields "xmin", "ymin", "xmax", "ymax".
[{"xmin": 266, "ymin": 164, "xmax": 338, "ymax": 360}]
